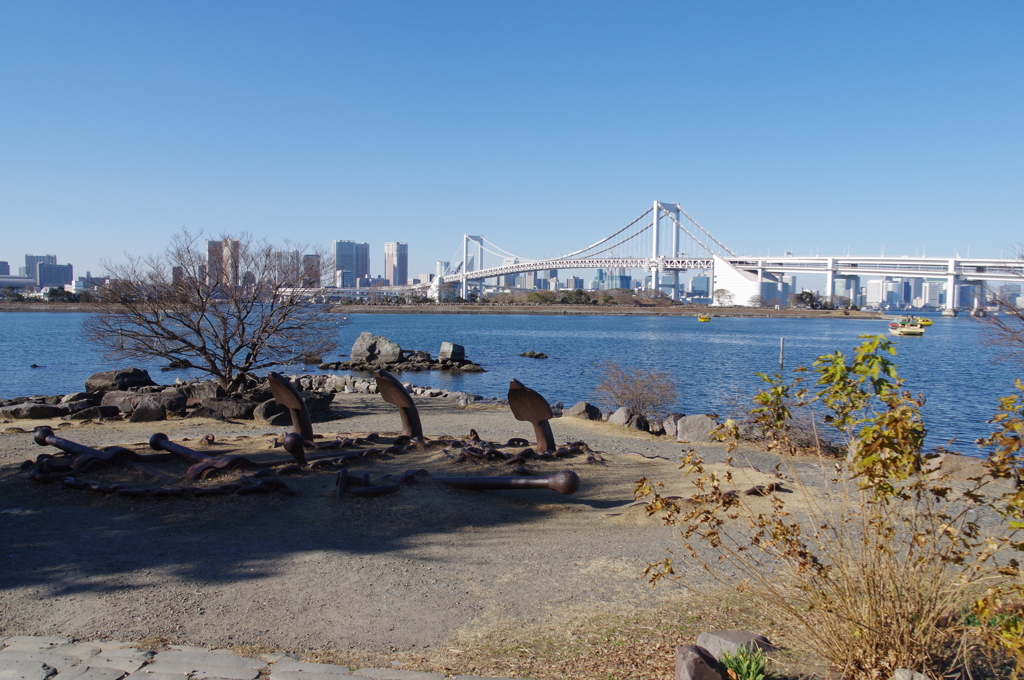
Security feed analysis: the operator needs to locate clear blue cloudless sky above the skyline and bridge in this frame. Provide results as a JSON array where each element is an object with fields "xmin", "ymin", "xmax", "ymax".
[{"xmin": 0, "ymin": 0, "xmax": 1024, "ymax": 275}]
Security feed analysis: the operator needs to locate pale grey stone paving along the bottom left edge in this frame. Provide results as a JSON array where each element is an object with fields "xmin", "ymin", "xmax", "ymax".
[{"xmin": 0, "ymin": 636, "xmax": 528, "ymax": 680}]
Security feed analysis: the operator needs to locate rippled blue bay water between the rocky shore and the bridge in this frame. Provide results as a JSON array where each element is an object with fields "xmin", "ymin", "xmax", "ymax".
[{"xmin": 0, "ymin": 312, "xmax": 1024, "ymax": 452}]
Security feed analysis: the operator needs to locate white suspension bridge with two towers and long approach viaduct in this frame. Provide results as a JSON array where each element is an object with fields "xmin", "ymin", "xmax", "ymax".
[{"xmin": 425, "ymin": 201, "xmax": 1024, "ymax": 309}]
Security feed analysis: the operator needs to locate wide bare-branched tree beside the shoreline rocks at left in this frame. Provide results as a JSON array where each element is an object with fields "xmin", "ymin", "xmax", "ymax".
[{"xmin": 84, "ymin": 229, "xmax": 343, "ymax": 393}]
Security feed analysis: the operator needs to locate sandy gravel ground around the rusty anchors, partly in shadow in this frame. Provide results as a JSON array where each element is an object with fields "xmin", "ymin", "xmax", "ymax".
[{"xmin": 0, "ymin": 394, "xmax": 806, "ymax": 653}]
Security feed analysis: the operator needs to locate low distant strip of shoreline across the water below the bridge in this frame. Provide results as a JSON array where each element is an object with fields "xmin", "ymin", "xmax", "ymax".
[{"xmin": 0, "ymin": 302, "xmax": 887, "ymax": 321}]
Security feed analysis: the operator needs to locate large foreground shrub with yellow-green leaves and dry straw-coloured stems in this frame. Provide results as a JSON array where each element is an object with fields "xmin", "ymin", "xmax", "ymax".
[{"xmin": 637, "ymin": 338, "xmax": 1024, "ymax": 679}]
